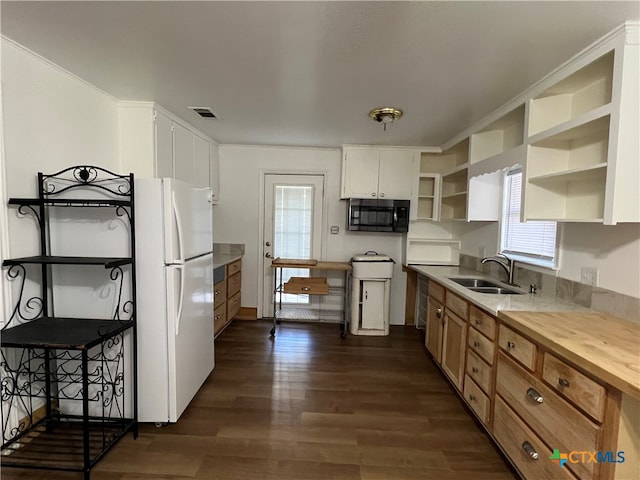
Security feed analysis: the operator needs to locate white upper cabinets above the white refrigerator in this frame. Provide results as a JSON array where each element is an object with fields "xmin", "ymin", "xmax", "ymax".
[{"xmin": 118, "ymin": 102, "xmax": 218, "ymax": 193}]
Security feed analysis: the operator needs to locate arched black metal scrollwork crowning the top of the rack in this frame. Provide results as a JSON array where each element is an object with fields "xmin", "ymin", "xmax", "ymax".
[{"xmin": 42, "ymin": 165, "xmax": 132, "ymax": 197}]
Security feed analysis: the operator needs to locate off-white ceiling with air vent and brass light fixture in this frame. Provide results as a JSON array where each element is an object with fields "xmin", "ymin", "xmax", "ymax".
[{"xmin": 0, "ymin": 0, "xmax": 640, "ymax": 147}]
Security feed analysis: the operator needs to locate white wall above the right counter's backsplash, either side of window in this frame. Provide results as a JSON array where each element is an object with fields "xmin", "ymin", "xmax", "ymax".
[{"xmin": 461, "ymin": 222, "xmax": 640, "ymax": 298}]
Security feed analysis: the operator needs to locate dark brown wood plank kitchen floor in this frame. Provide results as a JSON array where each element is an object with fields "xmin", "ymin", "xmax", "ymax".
[{"xmin": 2, "ymin": 321, "xmax": 514, "ymax": 480}]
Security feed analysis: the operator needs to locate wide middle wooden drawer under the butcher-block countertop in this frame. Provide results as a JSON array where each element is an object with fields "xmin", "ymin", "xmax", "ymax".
[{"xmin": 496, "ymin": 355, "xmax": 601, "ymax": 479}]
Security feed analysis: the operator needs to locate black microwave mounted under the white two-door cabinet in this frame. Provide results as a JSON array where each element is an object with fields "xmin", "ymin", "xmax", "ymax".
[{"xmin": 347, "ymin": 198, "xmax": 409, "ymax": 233}]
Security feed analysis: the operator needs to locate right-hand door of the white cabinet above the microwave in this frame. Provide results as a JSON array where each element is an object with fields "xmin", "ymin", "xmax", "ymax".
[{"xmin": 377, "ymin": 150, "xmax": 418, "ymax": 200}]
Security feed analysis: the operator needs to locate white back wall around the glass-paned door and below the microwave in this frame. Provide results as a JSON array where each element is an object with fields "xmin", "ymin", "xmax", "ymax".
[{"xmin": 213, "ymin": 145, "xmax": 406, "ymax": 324}]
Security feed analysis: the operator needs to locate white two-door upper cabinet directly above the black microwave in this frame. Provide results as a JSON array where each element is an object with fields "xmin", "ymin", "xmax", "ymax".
[{"xmin": 341, "ymin": 147, "xmax": 418, "ymax": 200}]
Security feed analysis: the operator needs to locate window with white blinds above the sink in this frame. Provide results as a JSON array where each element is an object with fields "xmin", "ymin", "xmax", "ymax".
[{"xmin": 500, "ymin": 168, "xmax": 558, "ymax": 267}]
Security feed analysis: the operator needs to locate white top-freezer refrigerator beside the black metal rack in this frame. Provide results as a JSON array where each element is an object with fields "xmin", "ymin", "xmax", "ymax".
[{"xmin": 135, "ymin": 178, "xmax": 214, "ymax": 423}]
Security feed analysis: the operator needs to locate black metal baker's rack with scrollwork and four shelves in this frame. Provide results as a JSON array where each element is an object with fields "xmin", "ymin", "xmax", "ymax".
[{"xmin": 0, "ymin": 165, "xmax": 138, "ymax": 480}]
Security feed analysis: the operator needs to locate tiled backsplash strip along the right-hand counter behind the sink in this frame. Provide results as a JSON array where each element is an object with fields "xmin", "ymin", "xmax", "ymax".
[{"xmin": 460, "ymin": 254, "xmax": 640, "ymax": 323}]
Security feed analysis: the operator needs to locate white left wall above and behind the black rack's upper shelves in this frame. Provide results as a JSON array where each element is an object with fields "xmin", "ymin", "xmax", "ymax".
[{"xmin": 2, "ymin": 38, "xmax": 120, "ymax": 256}]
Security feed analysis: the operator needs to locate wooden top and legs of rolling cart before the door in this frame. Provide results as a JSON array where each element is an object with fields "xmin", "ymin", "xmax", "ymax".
[{"xmin": 270, "ymin": 257, "xmax": 351, "ymax": 338}]
